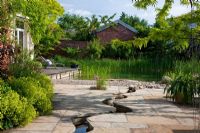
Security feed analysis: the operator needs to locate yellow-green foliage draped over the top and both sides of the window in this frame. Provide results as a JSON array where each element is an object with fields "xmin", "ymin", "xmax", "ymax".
[{"xmin": 0, "ymin": 0, "xmax": 64, "ymax": 54}]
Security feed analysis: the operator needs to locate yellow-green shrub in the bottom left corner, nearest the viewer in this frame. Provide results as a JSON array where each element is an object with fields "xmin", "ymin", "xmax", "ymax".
[{"xmin": 0, "ymin": 85, "xmax": 37, "ymax": 130}]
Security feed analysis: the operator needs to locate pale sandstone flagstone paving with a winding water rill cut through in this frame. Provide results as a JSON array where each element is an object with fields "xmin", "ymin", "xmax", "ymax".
[{"xmin": 3, "ymin": 79, "xmax": 198, "ymax": 133}]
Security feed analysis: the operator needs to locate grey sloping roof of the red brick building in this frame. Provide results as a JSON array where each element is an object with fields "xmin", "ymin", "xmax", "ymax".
[{"xmin": 96, "ymin": 20, "xmax": 138, "ymax": 33}]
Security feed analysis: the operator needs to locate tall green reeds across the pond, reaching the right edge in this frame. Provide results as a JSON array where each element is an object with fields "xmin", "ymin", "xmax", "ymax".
[{"xmin": 52, "ymin": 57, "xmax": 200, "ymax": 81}]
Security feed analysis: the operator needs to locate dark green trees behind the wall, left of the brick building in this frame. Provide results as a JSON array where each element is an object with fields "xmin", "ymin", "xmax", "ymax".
[{"xmin": 58, "ymin": 13, "xmax": 115, "ymax": 41}]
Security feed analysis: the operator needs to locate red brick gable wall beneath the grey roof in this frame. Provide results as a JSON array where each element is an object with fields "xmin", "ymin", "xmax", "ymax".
[{"xmin": 96, "ymin": 24, "xmax": 135, "ymax": 43}]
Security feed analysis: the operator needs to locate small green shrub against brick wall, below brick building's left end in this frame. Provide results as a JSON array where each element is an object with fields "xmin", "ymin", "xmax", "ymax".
[{"xmin": 87, "ymin": 40, "xmax": 104, "ymax": 59}]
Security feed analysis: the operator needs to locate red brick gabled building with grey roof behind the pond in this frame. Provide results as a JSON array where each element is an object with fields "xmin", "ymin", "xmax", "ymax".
[{"xmin": 96, "ymin": 20, "xmax": 137, "ymax": 43}]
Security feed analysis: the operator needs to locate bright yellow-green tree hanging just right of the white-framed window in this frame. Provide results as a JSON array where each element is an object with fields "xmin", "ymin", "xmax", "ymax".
[{"xmin": 23, "ymin": 0, "xmax": 64, "ymax": 53}]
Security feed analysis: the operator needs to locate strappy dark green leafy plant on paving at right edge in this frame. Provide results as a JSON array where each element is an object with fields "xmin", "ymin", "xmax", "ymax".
[{"xmin": 165, "ymin": 72, "xmax": 200, "ymax": 104}]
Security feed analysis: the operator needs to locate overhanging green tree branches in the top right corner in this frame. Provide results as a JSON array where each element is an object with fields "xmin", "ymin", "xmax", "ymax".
[{"xmin": 134, "ymin": 0, "xmax": 200, "ymax": 52}]
